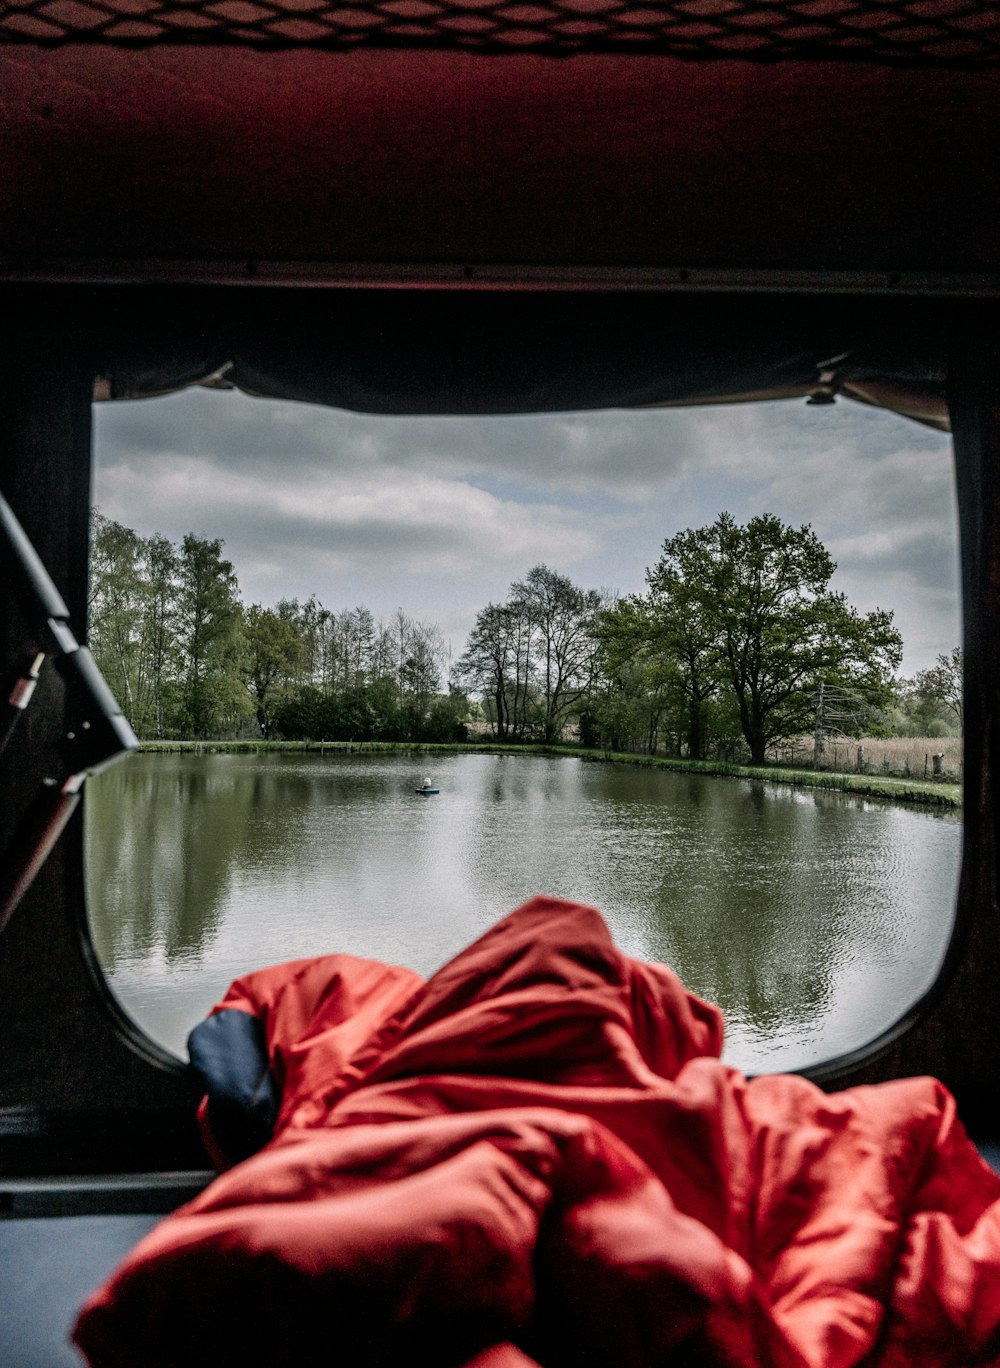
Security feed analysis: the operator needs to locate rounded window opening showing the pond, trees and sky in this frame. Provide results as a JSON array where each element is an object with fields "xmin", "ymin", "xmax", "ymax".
[{"xmin": 86, "ymin": 383, "xmax": 962, "ymax": 1071}]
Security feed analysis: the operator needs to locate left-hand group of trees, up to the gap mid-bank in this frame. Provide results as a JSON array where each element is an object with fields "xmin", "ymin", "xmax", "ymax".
[{"xmin": 89, "ymin": 510, "xmax": 469, "ymax": 740}]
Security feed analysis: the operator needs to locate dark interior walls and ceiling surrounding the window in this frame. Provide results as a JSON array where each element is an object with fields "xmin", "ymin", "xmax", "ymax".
[{"xmin": 0, "ymin": 8, "xmax": 1000, "ymax": 1368}]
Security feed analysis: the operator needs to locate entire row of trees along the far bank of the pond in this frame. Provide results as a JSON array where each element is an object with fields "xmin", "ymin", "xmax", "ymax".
[{"xmin": 89, "ymin": 510, "xmax": 962, "ymax": 763}]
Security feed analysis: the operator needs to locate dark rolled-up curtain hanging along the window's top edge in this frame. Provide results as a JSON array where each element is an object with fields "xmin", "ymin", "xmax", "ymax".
[{"xmin": 68, "ymin": 287, "xmax": 952, "ymax": 427}]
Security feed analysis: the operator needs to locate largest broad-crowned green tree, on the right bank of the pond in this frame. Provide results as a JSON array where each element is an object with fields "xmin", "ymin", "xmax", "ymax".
[{"xmin": 648, "ymin": 513, "xmax": 903, "ymax": 765}]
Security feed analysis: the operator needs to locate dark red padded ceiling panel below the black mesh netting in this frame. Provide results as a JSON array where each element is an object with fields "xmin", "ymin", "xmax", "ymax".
[{"xmin": 0, "ymin": 50, "xmax": 1000, "ymax": 299}]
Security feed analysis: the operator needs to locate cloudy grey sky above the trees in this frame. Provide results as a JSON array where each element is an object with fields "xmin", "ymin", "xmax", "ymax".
[{"xmin": 93, "ymin": 390, "xmax": 959, "ymax": 674}]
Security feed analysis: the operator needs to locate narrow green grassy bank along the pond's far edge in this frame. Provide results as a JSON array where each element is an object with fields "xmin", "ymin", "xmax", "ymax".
[{"xmin": 140, "ymin": 741, "xmax": 962, "ymax": 807}]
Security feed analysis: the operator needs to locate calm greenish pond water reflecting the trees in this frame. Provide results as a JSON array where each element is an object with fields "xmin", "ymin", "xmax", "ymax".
[{"xmin": 86, "ymin": 754, "xmax": 962, "ymax": 1071}]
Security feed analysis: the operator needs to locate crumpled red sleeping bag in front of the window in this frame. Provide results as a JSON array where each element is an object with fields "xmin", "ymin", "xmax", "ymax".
[{"xmin": 75, "ymin": 897, "xmax": 1000, "ymax": 1368}]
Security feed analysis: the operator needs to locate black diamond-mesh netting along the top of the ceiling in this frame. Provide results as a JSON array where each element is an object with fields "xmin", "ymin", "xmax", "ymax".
[{"xmin": 0, "ymin": 0, "xmax": 1000, "ymax": 67}]
